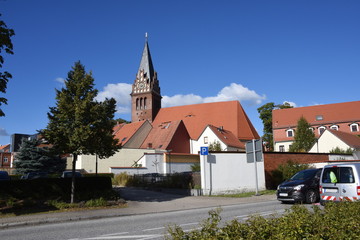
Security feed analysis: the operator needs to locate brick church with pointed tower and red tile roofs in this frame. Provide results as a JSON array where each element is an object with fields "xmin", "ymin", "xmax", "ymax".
[{"xmin": 114, "ymin": 38, "xmax": 259, "ymax": 154}]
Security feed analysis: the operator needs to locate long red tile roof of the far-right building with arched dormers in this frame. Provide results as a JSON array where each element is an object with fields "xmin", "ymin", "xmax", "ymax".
[{"xmin": 272, "ymin": 101, "xmax": 360, "ymax": 129}]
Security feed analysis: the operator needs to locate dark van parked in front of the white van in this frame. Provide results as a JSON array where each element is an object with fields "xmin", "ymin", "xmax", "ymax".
[{"xmin": 276, "ymin": 168, "xmax": 321, "ymax": 203}]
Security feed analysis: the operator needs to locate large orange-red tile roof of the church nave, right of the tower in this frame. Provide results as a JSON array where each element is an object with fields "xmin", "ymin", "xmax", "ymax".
[{"xmin": 153, "ymin": 101, "xmax": 260, "ymax": 140}]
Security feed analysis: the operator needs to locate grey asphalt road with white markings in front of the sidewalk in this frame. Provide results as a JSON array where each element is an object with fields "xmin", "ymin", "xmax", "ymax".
[{"xmin": 0, "ymin": 200, "xmax": 290, "ymax": 240}]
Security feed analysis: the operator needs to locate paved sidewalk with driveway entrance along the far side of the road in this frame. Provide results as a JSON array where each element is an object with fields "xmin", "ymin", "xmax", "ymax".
[{"xmin": 0, "ymin": 188, "xmax": 276, "ymax": 229}]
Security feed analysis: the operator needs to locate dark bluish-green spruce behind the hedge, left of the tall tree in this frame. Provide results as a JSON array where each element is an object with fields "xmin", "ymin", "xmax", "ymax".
[{"xmin": 14, "ymin": 138, "xmax": 66, "ymax": 174}]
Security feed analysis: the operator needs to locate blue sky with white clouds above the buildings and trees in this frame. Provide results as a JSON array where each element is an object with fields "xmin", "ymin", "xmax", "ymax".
[{"xmin": 0, "ymin": 0, "xmax": 360, "ymax": 145}]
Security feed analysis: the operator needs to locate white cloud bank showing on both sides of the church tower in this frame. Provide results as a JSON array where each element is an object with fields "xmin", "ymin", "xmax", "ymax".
[{"xmin": 97, "ymin": 83, "xmax": 266, "ymax": 113}]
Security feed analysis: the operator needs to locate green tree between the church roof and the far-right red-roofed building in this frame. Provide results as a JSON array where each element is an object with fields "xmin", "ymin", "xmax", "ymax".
[{"xmin": 257, "ymin": 102, "xmax": 292, "ymax": 152}]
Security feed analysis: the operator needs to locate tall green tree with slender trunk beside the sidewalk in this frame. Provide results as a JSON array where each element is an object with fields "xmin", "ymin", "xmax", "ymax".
[{"xmin": 43, "ymin": 61, "xmax": 120, "ymax": 203}]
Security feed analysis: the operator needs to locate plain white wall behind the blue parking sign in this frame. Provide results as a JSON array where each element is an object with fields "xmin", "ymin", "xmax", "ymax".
[{"xmin": 200, "ymin": 153, "xmax": 266, "ymax": 195}]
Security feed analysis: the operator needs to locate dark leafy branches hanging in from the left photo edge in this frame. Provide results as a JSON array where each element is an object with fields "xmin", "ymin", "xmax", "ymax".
[{"xmin": 0, "ymin": 14, "xmax": 15, "ymax": 117}]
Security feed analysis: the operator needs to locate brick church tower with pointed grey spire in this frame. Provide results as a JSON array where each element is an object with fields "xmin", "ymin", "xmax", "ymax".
[{"xmin": 130, "ymin": 33, "xmax": 162, "ymax": 122}]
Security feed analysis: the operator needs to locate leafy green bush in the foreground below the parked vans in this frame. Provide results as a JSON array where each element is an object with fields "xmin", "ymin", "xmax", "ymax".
[{"xmin": 166, "ymin": 202, "xmax": 360, "ymax": 240}]
